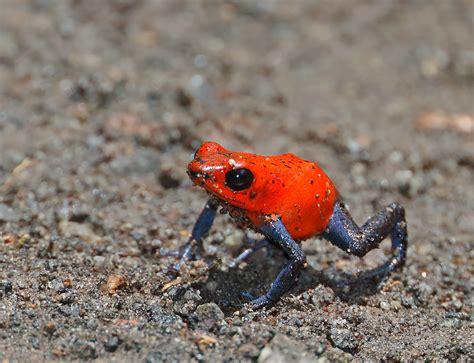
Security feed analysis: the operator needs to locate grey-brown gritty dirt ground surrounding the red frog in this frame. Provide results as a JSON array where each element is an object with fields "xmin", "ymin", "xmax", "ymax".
[{"xmin": 0, "ymin": 0, "xmax": 474, "ymax": 362}]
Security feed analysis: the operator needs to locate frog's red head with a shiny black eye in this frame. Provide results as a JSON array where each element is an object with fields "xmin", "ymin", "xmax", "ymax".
[{"xmin": 188, "ymin": 142, "xmax": 257, "ymax": 209}]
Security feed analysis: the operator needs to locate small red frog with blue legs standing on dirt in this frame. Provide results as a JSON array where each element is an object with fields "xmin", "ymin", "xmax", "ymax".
[{"xmin": 175, "ymin": 142, "xmax": 408, "ymax": 308}]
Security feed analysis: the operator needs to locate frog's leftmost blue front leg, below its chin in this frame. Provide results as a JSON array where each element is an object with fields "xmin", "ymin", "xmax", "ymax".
[{"xmin": 162, "ymin": 199, "xmax": 218, "ymax": 270}]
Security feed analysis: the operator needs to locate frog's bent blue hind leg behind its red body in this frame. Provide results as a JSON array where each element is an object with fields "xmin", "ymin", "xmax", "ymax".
[{"xmin": 322, "ymin": 202, "xmax": 408, "ymax": 277}]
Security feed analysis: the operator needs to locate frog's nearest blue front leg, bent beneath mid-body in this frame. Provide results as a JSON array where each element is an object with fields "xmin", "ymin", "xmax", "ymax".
[{"xmin": 250, "ymin": 218, "xmax": 306, "ymax": 309}]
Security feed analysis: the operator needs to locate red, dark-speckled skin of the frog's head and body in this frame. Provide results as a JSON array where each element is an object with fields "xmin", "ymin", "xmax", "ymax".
[{"xmin": 188, "ymin": 142, "xmax": 338, "ymax": 240}]
